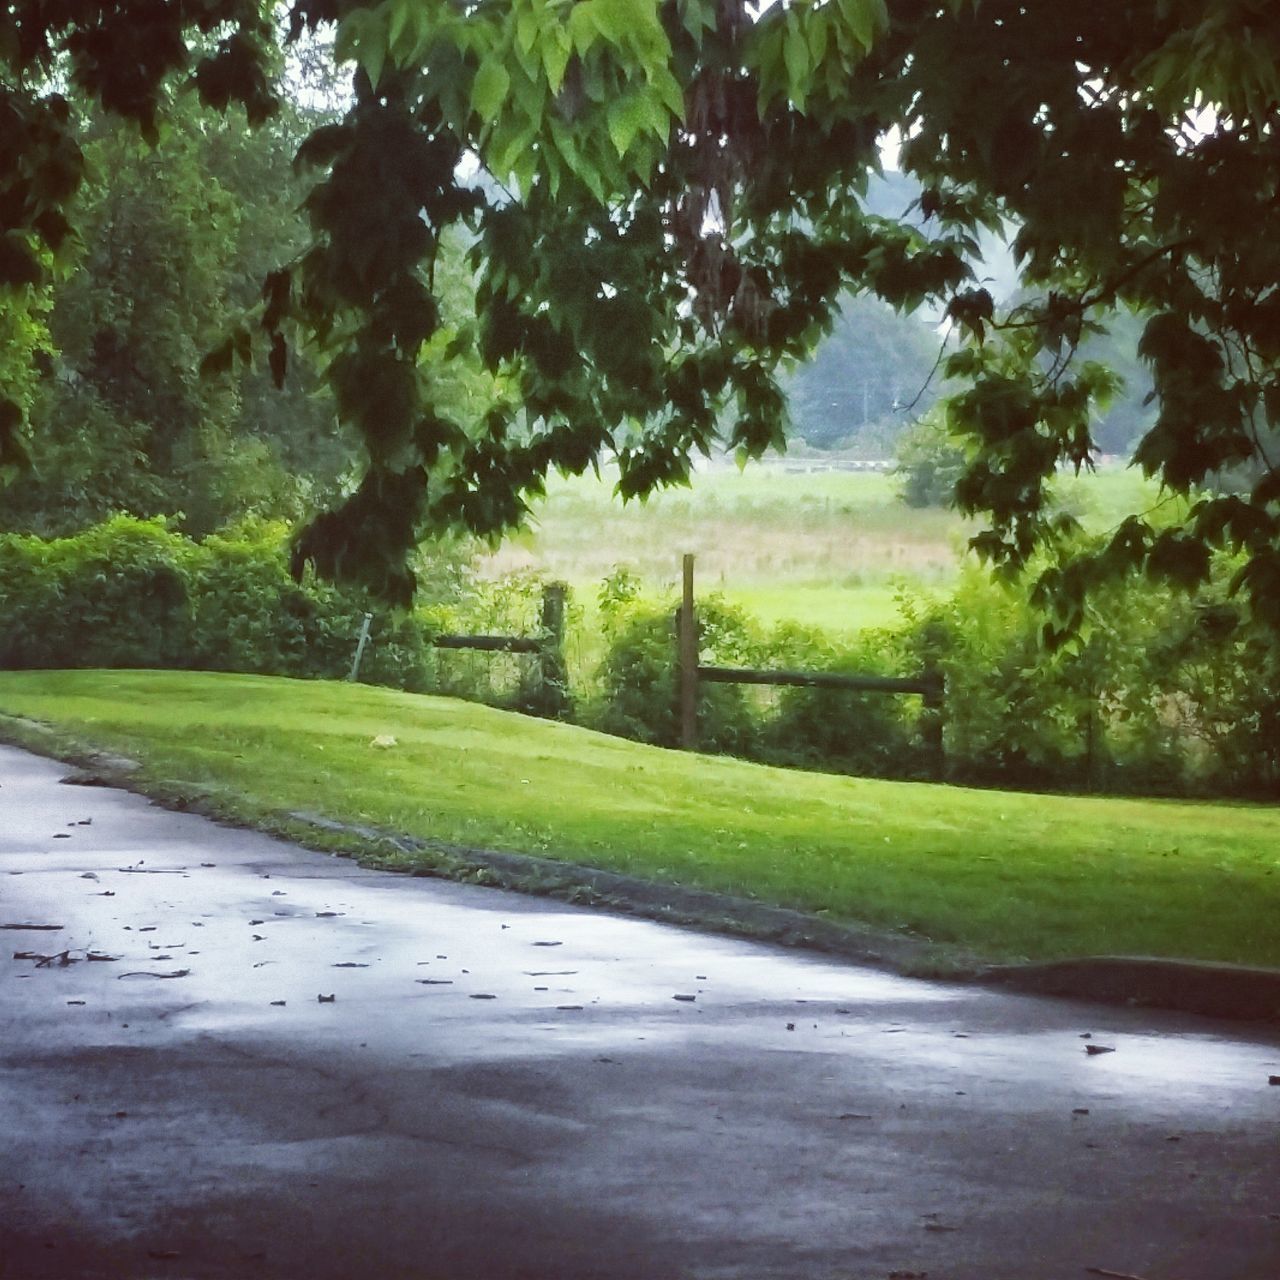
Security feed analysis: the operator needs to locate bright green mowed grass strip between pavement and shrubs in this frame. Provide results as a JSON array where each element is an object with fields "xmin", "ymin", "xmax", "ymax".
[{"xmin": 0, "ymin": 671, "xmax": 1280, "ymax": 965}]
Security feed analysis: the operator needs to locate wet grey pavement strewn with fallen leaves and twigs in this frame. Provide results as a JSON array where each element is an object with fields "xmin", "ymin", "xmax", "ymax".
[{"xmin": 0, "ymin": 748, "xmax": 1280, "ymax": 1280}]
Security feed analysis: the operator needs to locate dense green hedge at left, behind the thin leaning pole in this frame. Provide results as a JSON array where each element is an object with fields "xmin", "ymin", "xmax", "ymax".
[{"xmin": 0, "ymin": 516, "xmax": 426, "ymax": 689}]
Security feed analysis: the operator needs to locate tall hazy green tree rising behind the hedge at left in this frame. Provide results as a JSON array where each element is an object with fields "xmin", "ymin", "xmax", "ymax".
[{"xmin": 0, "ymin": 90, "xmax": 355, "ymax": 534}]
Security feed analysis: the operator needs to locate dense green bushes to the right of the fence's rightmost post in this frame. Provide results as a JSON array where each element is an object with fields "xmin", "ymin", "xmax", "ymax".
[{"xmin": 911, "ymin": 564, "xmax": 1280, "ymax": 795}]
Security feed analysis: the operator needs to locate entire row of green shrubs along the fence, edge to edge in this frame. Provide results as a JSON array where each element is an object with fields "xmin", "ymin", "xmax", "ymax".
[{"xmin": 0, "ymin": 516, "xmax": 1280, "ymax": 796}]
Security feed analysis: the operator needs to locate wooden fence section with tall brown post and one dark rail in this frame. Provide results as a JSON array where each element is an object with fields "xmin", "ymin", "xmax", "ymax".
[{"xmin": 676, "ymin": 556, "xmax": 946, "ymax": 778}]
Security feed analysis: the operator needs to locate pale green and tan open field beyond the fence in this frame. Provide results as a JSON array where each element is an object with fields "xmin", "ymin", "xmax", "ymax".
[{"xmin": 483, "ymin": 460, "xmax": 1172, "ymax": 634}]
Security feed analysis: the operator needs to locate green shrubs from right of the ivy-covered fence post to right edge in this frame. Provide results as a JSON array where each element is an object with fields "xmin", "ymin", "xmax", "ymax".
[{"xmin": 584, "ymin": 567, "xmax": 1280, "ymax": 797}]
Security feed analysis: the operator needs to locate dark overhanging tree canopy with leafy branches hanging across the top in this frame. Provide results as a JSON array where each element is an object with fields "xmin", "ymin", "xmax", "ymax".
[{"xmin": 0, "ymin": 0, "xmax": 1280, "ymax": 635}]
